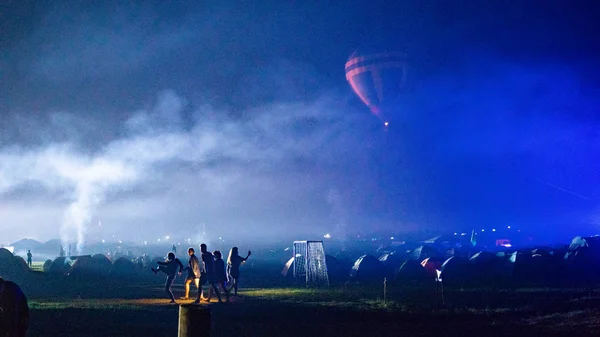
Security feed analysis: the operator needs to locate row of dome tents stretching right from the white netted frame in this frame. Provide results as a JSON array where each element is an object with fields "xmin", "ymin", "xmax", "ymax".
[{"xmin": 286, "ymin": 236, "xmax": 600, "ymax": 286}]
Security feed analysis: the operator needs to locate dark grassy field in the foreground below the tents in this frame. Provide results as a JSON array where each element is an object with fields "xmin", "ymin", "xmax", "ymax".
[{"xmin": 8, "ymin": 262, "xmax": 600, "ymax": 337}]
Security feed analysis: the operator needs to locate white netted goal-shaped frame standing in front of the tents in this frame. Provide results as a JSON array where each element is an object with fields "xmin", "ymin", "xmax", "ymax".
[{"xmin": 294, "ymin": 241, "xmax": 329, "ymax": 287}]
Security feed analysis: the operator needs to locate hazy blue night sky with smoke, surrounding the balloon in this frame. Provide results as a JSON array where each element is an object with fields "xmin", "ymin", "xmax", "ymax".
[{"xmin": 0, "ymin": 0, "xmax": 600, "ymax": 247}]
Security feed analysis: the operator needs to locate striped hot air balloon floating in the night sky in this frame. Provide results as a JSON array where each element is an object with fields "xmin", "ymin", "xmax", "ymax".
[{"xmin": 346, "ymin": 48, "xmax": 407, "ymax": 127}]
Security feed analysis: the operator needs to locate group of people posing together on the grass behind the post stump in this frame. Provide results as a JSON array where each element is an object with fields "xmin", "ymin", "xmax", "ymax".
[{"xmin": 151, "ymin": 243, "xmax": 252, "ymax": 303}]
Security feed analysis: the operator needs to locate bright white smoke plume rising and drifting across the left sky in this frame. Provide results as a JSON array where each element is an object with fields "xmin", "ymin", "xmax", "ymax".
[{"xmin": 0, "ymin": 91, "xmax": 352, "ymax": 252}]
